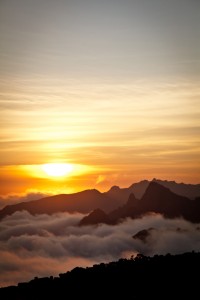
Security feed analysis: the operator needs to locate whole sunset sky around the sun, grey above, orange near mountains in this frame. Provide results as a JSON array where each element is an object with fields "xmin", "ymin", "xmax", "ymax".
[{"xmin": 0, "ymin": 0, "xmax": 200, "ymax": 196}]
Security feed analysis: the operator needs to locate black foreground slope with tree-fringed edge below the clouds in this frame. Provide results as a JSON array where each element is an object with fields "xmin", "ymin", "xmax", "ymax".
[{"xmin": 0, "ymin": 252, "xmax": 200, "ymax": 300}]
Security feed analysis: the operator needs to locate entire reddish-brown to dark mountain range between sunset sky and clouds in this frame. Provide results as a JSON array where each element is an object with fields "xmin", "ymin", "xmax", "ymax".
[{"xmin": 0, "ymin": 179, "xmax": 200, "ymax": 223}]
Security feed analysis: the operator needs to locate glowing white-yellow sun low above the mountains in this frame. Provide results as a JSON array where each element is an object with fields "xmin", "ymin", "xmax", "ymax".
[{"xmin": 42, "ymin": 163, "xmax": 73, "ymax": 177}]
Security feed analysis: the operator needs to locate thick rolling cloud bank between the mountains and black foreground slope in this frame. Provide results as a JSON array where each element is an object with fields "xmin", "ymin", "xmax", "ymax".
[{"xmin": 0, "ymin": 211, "xmax": 200, "ymax": 286}]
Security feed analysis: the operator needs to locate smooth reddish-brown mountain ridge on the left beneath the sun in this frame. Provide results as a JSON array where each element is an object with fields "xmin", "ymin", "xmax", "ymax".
[{"xmin": 0, "ymin": 190, "xmax": 117, "ymax": 219}]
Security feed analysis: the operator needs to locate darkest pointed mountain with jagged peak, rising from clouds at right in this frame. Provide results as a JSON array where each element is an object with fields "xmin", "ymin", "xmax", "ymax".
[{"xmin": 80, "ymin": 181, "xmax": 200, "ymax": 224}]
